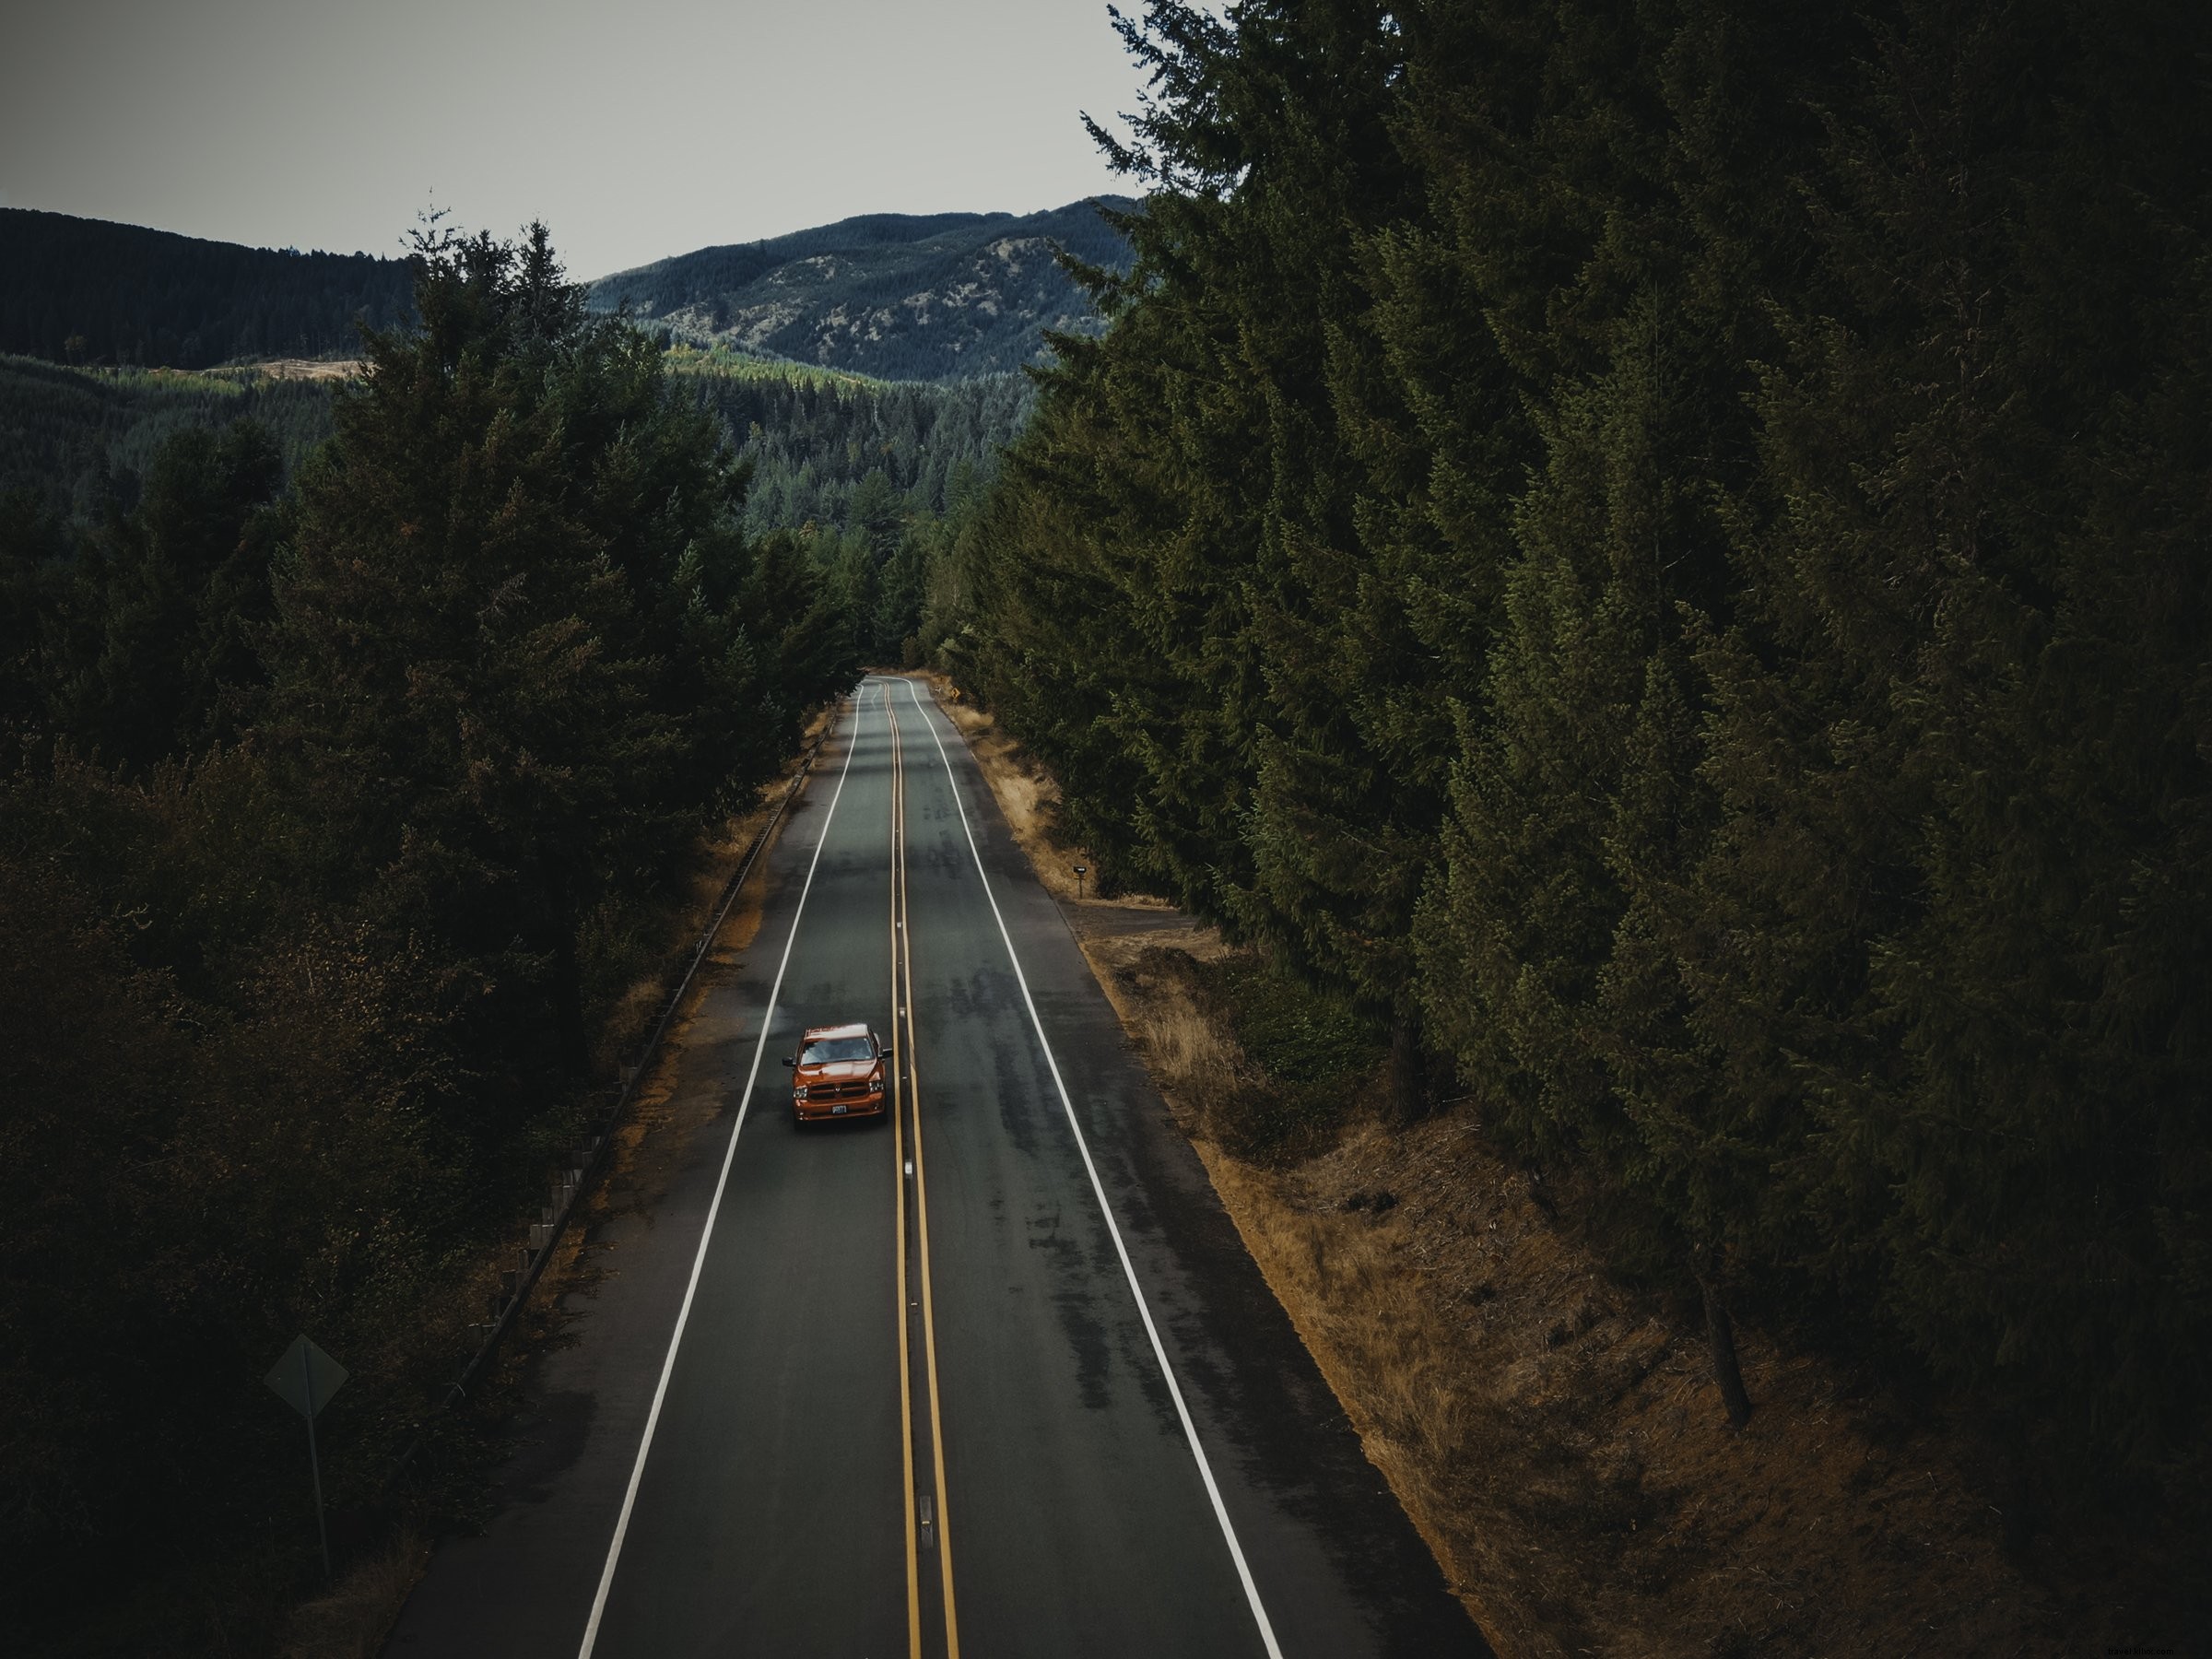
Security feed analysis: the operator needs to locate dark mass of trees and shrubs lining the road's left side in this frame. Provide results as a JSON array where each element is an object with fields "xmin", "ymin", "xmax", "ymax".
[{"xmin": 0, "ymin": 230, "xmax": 858, "ymax": 1653}]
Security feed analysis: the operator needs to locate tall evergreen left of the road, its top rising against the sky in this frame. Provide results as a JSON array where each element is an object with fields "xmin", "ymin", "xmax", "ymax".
[{"xmin": 272, "ymin": 228, "xmax": 825, "ymax": 1092}]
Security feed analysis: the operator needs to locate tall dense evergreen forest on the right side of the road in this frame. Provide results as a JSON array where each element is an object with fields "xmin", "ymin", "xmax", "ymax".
[{"xmin": 947, "ymin": 0, "xmax": 2212, "ymax": 1498}]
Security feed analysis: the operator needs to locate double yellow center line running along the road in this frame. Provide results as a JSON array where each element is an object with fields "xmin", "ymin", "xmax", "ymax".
[{"xmin": 883, "ymin": 686, "xmax": 960, "ymax": 1659}]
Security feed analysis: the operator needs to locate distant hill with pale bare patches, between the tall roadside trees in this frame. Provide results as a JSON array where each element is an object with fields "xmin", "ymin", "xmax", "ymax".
[{"xmin": 591, "ymin": 197, "xmax": 1135, "ymax": 381}]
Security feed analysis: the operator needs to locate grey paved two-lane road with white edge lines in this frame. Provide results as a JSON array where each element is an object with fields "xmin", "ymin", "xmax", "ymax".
[{"xmin": 387, "ymin": 677, "xmax": 1487, "ymax": 1659}]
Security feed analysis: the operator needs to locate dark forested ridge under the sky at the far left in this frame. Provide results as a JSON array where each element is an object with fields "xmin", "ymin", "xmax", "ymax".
[{"xmin": 0, "ymin": 208, "xmax": 414, "ymax": 370}]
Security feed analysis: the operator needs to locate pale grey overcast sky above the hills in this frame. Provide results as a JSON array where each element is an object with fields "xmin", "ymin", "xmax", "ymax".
[{"xmin": 0, "ymin": 0, "xmax": 1141, "ymax": 276}]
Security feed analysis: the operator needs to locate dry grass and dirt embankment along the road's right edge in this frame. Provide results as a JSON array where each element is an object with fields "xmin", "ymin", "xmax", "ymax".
[{"xmin": 940, "ymin": 686, "xmax": 2199, "ymax": 1659}]
